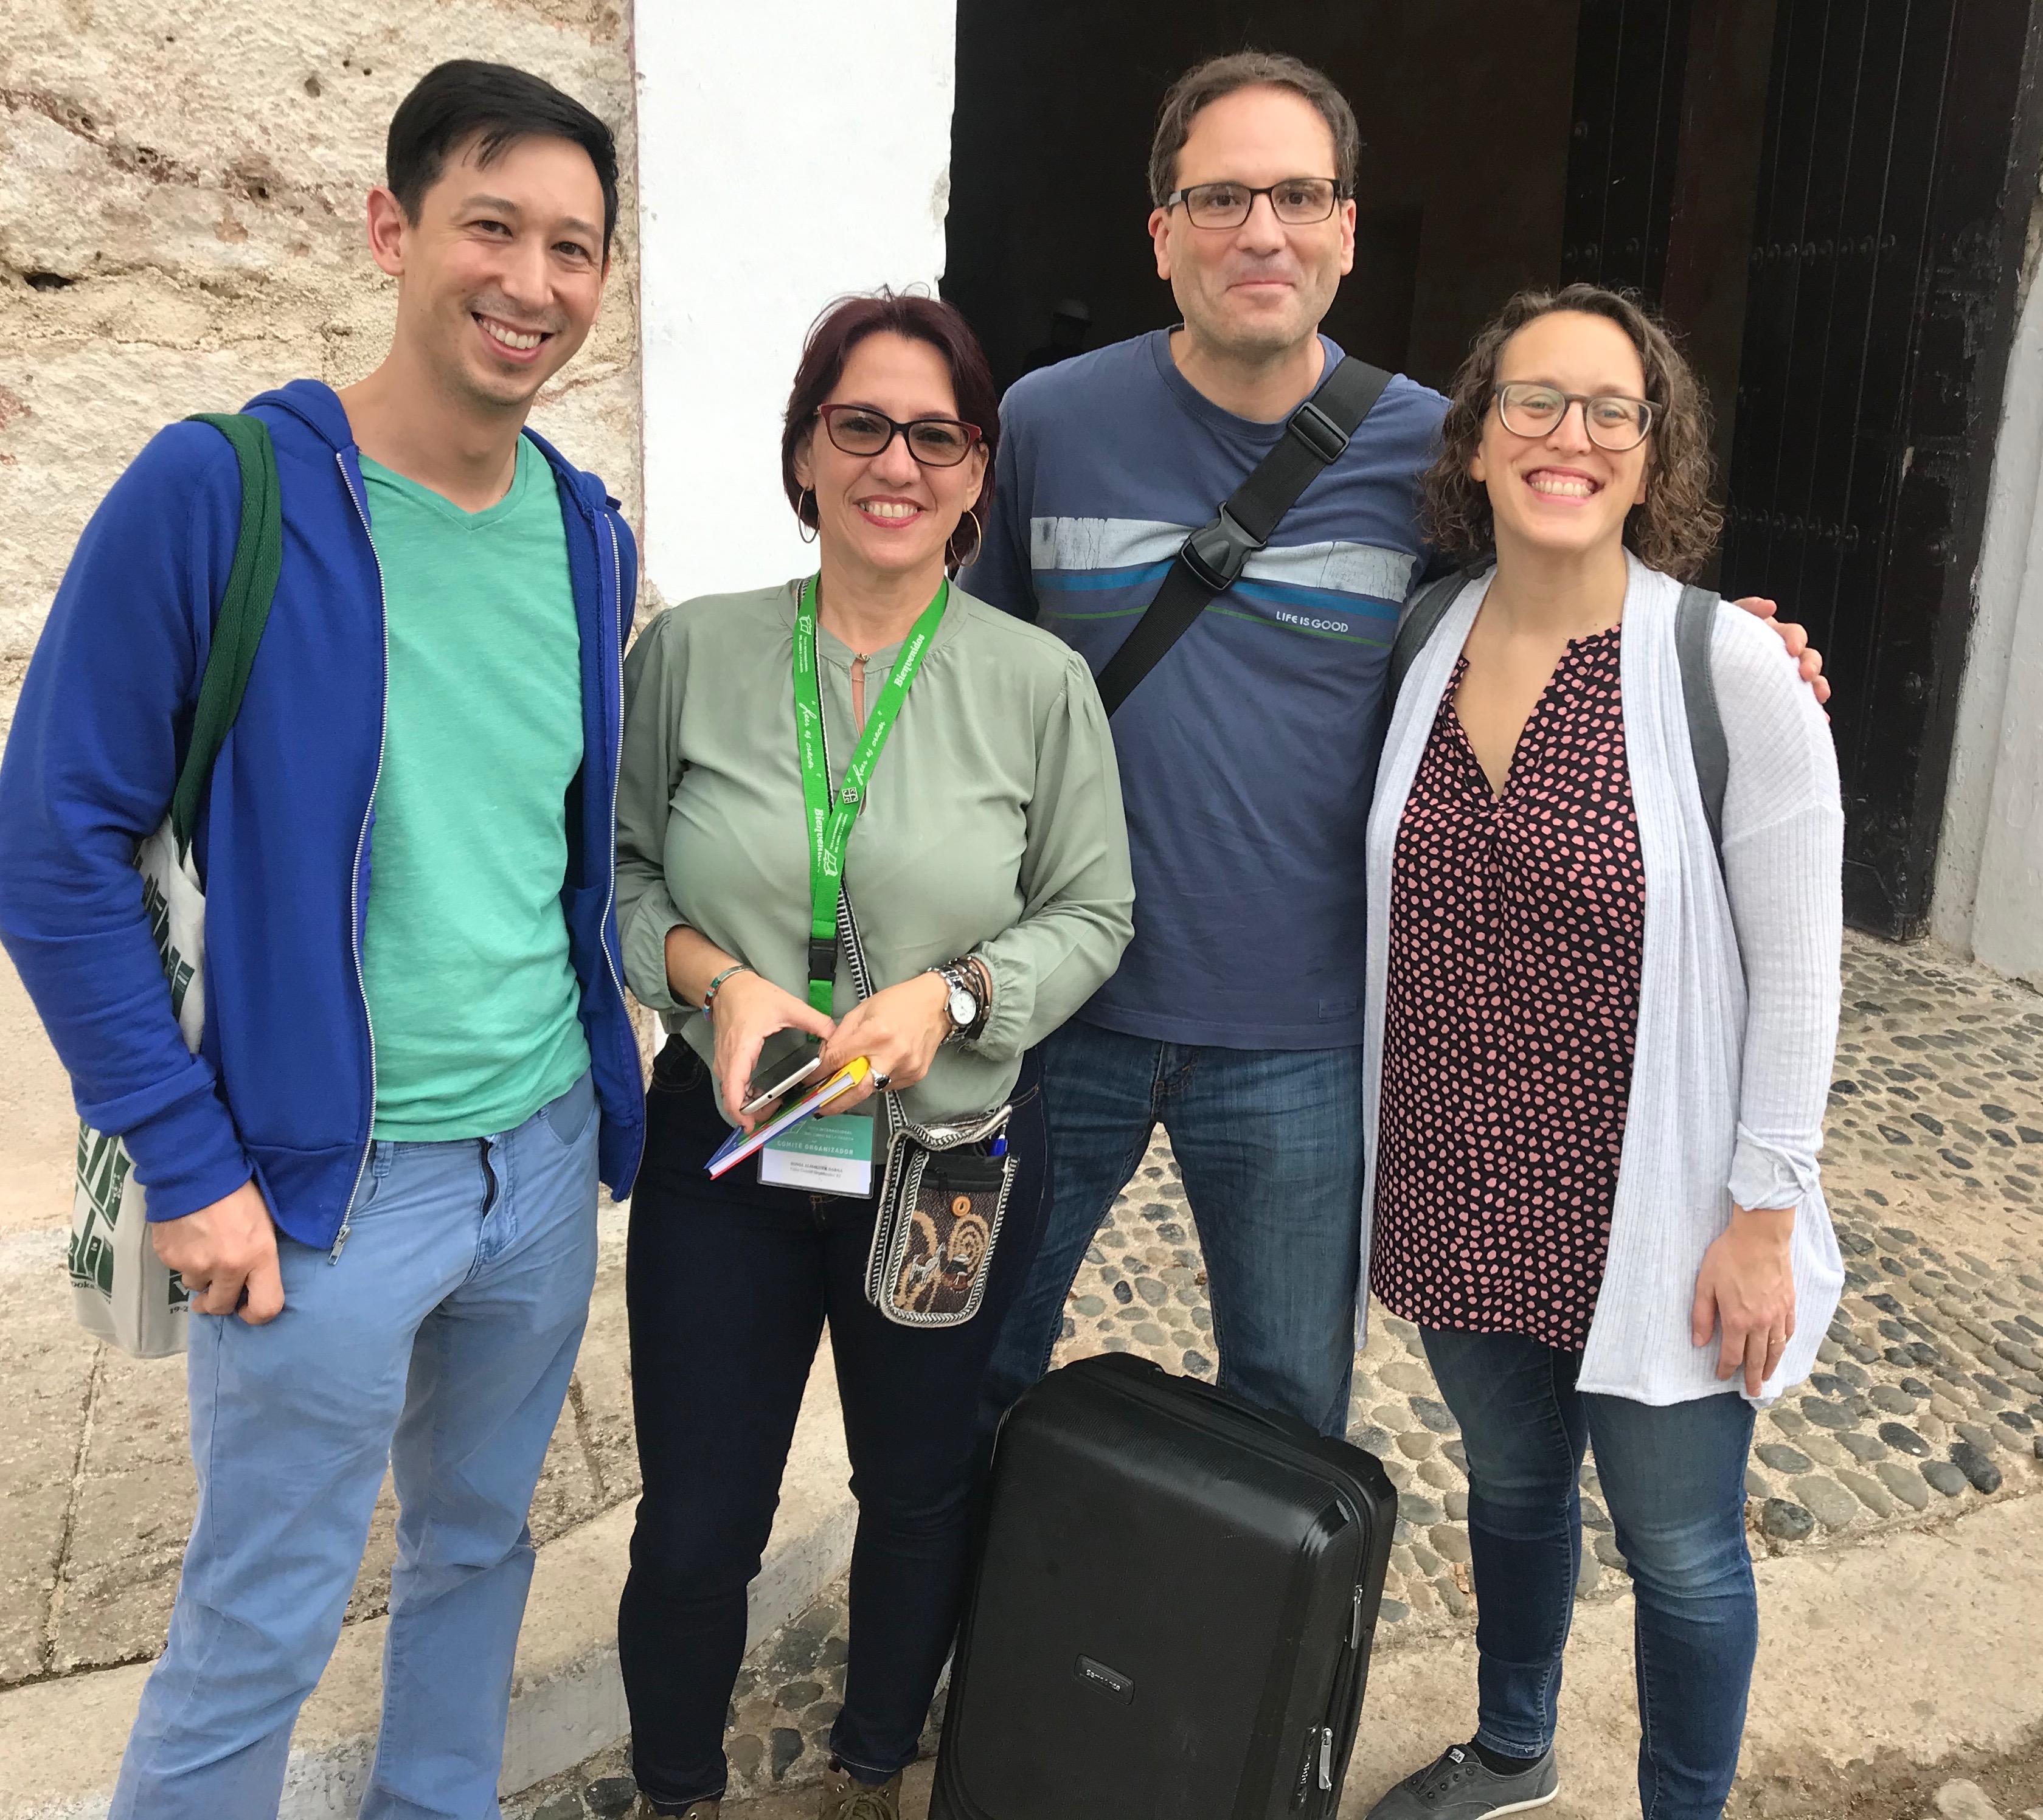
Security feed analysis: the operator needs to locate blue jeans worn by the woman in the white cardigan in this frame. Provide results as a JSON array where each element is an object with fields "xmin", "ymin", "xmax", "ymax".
[{"xmin": 1420, "ymin": 1327, "xmax": 1759, "ymax": 1820}]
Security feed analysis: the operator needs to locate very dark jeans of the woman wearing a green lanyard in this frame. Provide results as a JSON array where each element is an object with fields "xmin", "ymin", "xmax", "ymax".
[{"xmin": 617, "ymin": 1037, "xmax": 1050, "ymax": 1814}]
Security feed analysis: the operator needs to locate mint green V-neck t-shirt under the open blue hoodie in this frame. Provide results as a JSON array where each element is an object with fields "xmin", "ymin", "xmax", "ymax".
[{"xmin": 362, "ymin": 437, "xmax": 588, "ymax": 1142}]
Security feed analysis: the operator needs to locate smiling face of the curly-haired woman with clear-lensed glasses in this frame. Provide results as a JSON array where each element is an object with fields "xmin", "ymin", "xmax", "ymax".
[{"xmin": 1469, "ymin": 311, "xmax": 1653, "ymax": 556}]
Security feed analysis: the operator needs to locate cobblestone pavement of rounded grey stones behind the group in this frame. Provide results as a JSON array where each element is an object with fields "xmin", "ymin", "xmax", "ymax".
[{"xmin": 505, "ymin": 935, "xmax": 2043, "ymax": 1820}]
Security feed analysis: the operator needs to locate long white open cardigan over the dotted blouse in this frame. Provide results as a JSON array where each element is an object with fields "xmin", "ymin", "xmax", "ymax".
[{"xmin": 1361, "ymin": 556, "xmax": 1845, "ymax": 1403}]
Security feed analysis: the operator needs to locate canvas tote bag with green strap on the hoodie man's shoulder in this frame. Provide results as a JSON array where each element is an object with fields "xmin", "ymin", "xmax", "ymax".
[{"xmin": 69, "ymin": 413, "xmax": 284, "ymax": 1358}]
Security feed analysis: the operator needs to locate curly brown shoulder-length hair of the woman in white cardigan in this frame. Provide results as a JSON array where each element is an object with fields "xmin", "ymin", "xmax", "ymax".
[{"xmin": 1422, "ymin": 284, "xmax": 1724, "ymax": 582}]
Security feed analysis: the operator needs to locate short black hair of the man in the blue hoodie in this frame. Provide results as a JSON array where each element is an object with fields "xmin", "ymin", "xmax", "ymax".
[{"xmin": 384, "ymin": 57, "xmax": 617, "ymax": 260}]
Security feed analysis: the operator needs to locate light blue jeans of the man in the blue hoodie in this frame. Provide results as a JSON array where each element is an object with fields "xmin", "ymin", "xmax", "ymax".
[{"xmin": 110, "ymin": 1074, "xmax": 598, "ymax": 1820}]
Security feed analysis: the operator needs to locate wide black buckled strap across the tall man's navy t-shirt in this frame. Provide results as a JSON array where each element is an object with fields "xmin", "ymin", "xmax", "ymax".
[{"xmin": 1099, "ymin": 355, "xmax": 1391, "ymax": 715}]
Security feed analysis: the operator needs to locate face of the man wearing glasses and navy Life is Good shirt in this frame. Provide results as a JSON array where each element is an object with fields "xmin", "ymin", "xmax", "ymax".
[{"xmin": 1150, "ymin": 86, "xmax": 1354, "ymax": 359}]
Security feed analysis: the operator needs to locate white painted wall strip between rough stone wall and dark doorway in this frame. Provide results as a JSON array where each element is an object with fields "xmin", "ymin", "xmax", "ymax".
[{"xmin": 636, "ymin": 0, "xmax": 956, "ymax": 603}]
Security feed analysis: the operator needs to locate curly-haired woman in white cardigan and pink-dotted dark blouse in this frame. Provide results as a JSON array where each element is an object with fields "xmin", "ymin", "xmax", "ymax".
[{"xmin": 1362, "ymin": 286, "xmax": 1843, "ymax": 1820}]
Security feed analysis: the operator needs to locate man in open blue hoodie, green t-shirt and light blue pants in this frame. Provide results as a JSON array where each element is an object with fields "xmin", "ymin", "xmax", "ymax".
[{"xmin": 0, "ymin": 63, "xmax": 642, "ymax": 1820}]
